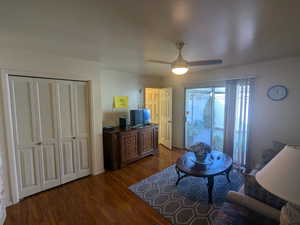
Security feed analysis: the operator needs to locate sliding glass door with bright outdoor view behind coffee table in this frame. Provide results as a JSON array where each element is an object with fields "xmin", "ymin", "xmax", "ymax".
[{"xmin": 185, "ymin": 87, "xmax": 225, "ymax": 151}]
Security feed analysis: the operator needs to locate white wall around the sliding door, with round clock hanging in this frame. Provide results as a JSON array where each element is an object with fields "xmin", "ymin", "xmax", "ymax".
[{"xmin": 165, "ymin": 58, "xmax": 300, "ymax": 167}]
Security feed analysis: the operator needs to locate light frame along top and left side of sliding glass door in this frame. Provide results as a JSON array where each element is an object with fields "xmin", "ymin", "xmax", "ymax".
[{"xmin": 183, "ymin": 81, "xmax": 226, "ymax": 149}]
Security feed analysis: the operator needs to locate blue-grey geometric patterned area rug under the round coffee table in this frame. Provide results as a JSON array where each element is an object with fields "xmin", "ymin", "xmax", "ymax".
[{"xmin": 129, "ymin": 165, "xmax": 243, "ymax": 225}]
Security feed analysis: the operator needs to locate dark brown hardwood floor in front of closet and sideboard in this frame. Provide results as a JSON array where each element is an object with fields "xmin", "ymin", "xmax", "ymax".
[{"xmin": 5, "ymin": 146, "xmax": 183, "ymax": 225}]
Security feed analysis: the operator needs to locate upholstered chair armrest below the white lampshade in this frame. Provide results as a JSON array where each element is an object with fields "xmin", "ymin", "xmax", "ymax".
[{"xmin": 226, "ymin": 191, "xmax": 280, "ymax": 222}]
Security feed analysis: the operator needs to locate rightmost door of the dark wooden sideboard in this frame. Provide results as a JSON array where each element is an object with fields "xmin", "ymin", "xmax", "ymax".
[{"xmin": 139, "ymin": 127, "xmax": 153, "ymax": 155}]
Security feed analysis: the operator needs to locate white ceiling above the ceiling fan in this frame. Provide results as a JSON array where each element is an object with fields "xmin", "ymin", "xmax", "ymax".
[{"xmin": 0, "ymin": 0, "xmax": 300, "ymax": 75}]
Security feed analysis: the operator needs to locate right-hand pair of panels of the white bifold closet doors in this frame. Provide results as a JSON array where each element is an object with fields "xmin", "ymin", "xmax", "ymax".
[{"xmin": 58, "ymin": 81, "xmax": 90, "ymax": 183}]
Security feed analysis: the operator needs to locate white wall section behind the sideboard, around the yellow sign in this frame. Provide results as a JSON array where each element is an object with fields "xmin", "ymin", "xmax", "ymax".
[{"xmin": 101, "ymin": 70, "xmax": 162, "ymax": 126}]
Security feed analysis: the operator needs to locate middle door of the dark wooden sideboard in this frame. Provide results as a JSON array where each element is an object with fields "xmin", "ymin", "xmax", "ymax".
[{"xmin": 120, "ymin": 131, "xmax": 139, "ymax": 166}]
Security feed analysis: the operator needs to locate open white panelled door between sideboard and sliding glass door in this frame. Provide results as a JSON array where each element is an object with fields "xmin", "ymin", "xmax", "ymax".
[{"xmin": 159, "ymin": 88, "xmax": 173, "ymax": 149}]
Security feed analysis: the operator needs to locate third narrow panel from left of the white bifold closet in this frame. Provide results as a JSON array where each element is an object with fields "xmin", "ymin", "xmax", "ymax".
[{"xmin": 56, "ymin": 81, "xmax": 78, "ymax": 183}]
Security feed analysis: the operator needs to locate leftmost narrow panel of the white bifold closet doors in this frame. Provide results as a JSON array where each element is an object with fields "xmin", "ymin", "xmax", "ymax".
[{"xmin": 9, "ymin": 76, "xmax": 42, "ymax": 198}]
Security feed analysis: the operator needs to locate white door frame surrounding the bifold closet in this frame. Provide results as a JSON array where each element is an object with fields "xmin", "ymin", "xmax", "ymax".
[{"xmin": 0, "ymin": 69, "xmax": 97, "ymax": 206}]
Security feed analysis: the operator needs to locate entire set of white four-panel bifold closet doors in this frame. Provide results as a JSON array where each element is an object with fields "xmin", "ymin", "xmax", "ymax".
[{"xmin": 9, "ymin": 76, "xmax": 90, "ymax": 197}]
